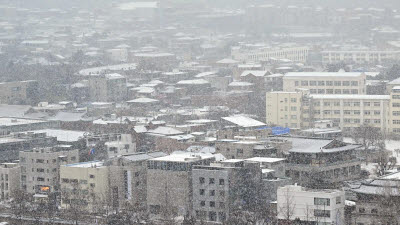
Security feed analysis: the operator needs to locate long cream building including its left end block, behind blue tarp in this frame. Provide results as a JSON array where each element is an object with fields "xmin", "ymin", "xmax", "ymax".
[{"xmin": 266, "ymin": 91, "xmax": 390, "ymax": 132}]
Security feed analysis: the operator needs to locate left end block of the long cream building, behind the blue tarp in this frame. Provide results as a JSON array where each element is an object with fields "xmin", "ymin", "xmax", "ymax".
[{"xmin": 266, "ymin": 91, "xmax": 305, "ymax": 128}]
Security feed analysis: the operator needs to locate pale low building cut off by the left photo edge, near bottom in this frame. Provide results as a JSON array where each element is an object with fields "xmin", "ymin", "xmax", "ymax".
[{"xmin": 0, "ymin": 163, "xmax": 21, "ymax": 201}]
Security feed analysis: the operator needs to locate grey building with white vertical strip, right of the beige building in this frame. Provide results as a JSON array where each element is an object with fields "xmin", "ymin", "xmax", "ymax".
[{"xmin": 105, "ymin": 152, "xmax": 167, "ymax": 208}]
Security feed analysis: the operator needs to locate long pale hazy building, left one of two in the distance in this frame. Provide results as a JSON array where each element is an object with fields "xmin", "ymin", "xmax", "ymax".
[{"xmin": 231, "ymin": 45, "xmax": 309, "ymax": 62}]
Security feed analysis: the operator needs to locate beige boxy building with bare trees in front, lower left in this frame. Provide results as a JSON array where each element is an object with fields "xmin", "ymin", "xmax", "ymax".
[{"xmin": 60, "ymin": 161, "xmax": 109, "ymax": 212}]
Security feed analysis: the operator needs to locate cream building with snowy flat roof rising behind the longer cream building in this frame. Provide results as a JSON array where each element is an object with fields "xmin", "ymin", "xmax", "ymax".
[{"xmin": 283, "ymin": 72, "xmax": 366, "ymax": 95}]
